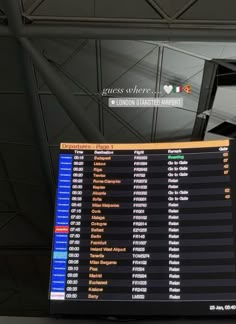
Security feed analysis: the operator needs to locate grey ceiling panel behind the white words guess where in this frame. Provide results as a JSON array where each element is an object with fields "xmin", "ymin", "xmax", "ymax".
[{"xmin": 102, "ymin": 41, "xmax": 159, "ymax": 142}]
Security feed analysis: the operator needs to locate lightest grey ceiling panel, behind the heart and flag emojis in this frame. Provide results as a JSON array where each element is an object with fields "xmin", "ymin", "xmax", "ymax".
[{"xmin": 156, "ymin": 48, "xmax": 205, "ymax": 141}]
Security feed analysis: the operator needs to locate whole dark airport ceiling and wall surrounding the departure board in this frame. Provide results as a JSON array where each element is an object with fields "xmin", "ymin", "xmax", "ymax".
[{"xmin": 0, "ymin": 0, "xmax": 236, "ymax": 315}]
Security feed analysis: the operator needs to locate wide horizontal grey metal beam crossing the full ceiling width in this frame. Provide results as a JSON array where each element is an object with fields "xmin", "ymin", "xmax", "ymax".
[{"xmin": 0, "ymin": 20, "xmax": 236, "ymax": 42}]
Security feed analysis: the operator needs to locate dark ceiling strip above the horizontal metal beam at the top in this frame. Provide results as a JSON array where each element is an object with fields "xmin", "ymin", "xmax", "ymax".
[{"xmin": 13, "ymin": 0, "xmax": 235, "ymax": 25}]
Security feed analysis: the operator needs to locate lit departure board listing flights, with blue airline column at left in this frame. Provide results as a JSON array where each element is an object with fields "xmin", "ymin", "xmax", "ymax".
[{"xmin": 50, "ymin": 140, "xmax": 236, "ymax": 315}]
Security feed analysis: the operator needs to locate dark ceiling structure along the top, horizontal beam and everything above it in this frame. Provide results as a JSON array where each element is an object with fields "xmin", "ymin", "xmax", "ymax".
[{"xmin": 0, "ymin": 0, "xmax": 235, "ymax": 41}]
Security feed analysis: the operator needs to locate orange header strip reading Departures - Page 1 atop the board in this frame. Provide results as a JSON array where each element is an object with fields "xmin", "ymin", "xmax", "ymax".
[{"xmin": 60, "ymin": 140, "xmax": 230, "ymax": 151}]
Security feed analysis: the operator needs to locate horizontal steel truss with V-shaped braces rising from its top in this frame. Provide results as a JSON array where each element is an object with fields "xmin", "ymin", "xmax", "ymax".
[{"xmin": 0, "ymin": 0, "xmax": 236, "ymax": 41}]
